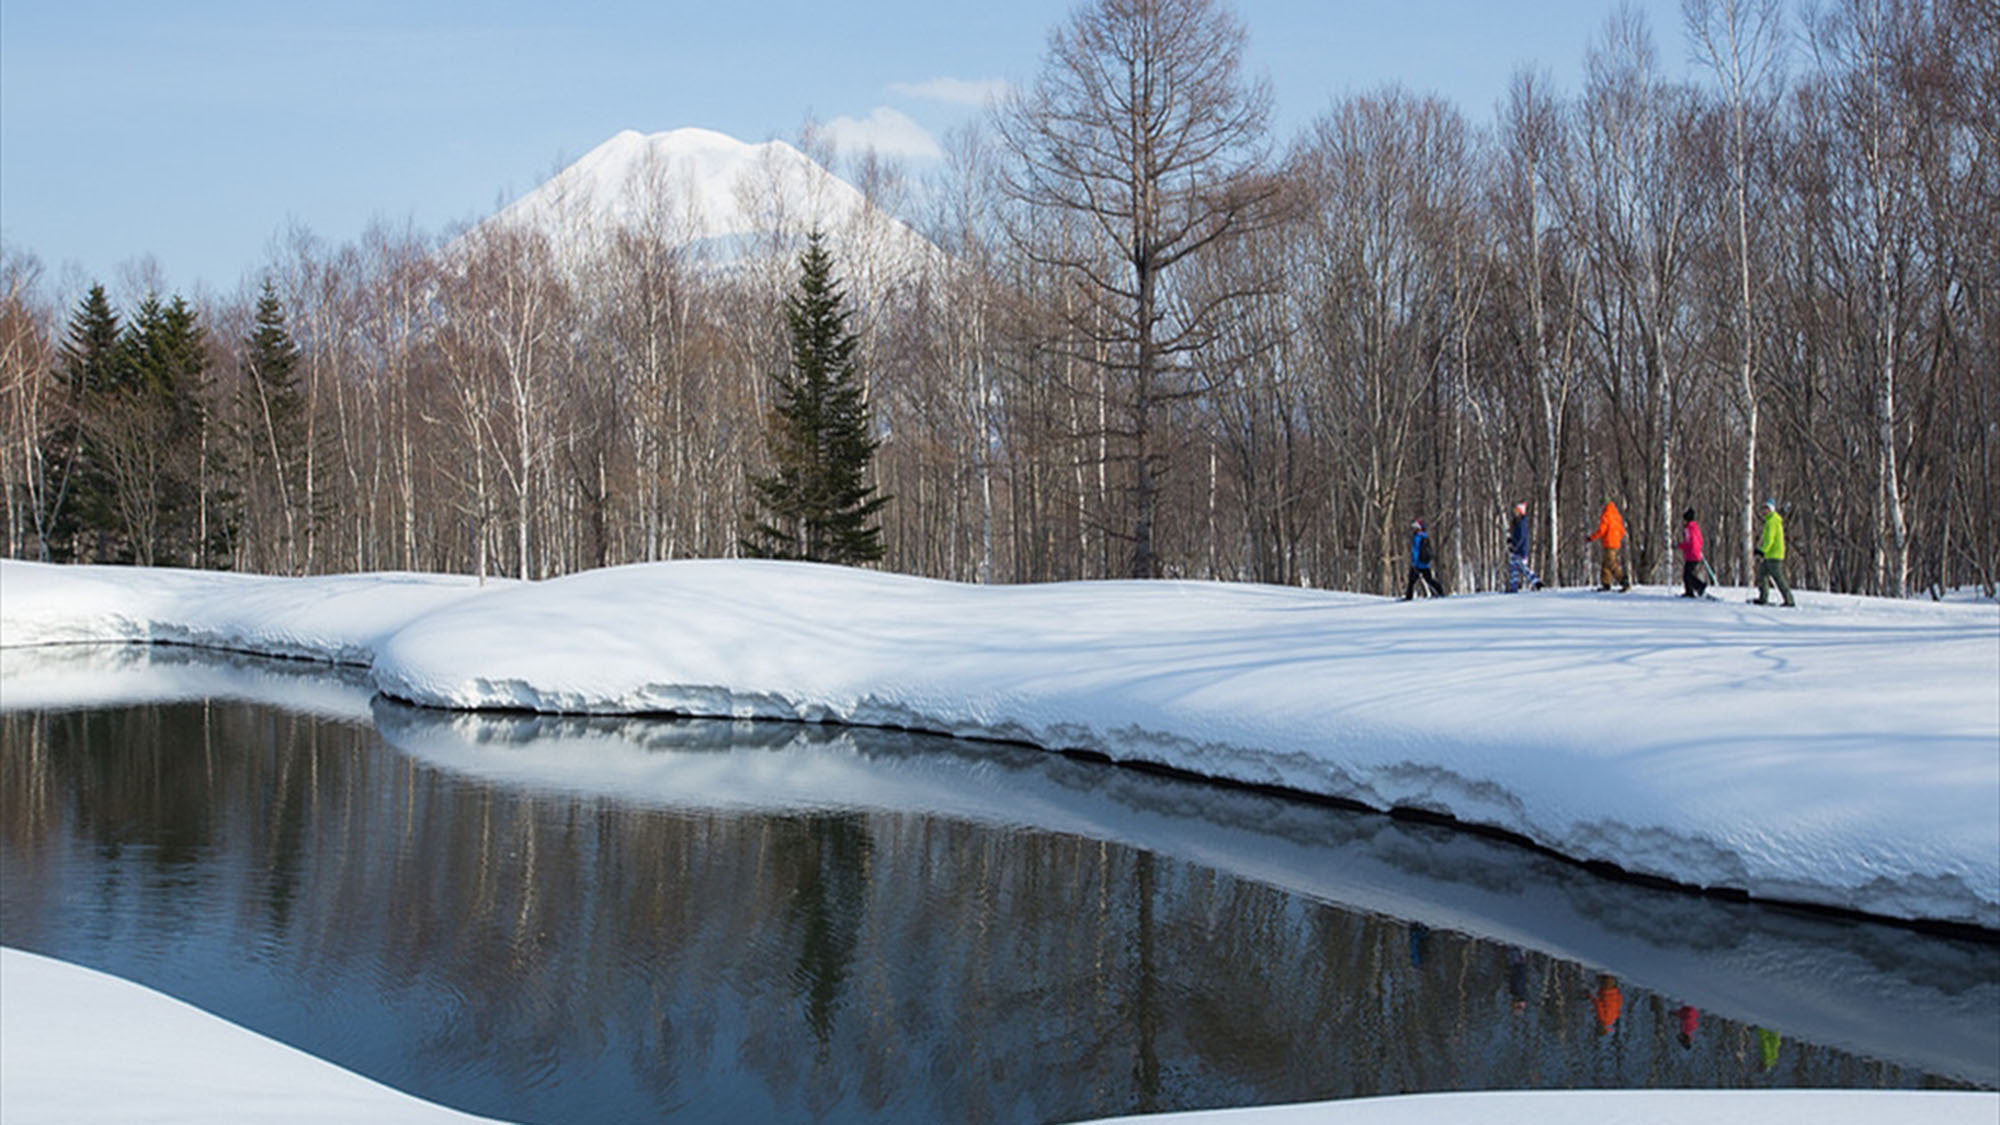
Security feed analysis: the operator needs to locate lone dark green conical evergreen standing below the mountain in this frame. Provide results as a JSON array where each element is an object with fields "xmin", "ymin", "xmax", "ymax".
[{"xmin": 740, "ymin": 232, "xmax": 890, "ymax": 565}]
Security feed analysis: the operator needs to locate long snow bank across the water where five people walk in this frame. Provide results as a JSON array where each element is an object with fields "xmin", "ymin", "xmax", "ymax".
[{"xmin": 0, "ymin": 560, "xmax": 2000, "ymax": 929}]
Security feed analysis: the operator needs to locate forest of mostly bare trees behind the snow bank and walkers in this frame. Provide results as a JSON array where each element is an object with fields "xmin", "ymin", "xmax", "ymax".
[{"xmin": 0, "ymin": 0, "xmax": 2000, "ymax": 595}]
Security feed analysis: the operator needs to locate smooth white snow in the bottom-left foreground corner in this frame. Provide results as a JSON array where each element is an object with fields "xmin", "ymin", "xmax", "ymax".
[{"xmin": 0, "ymin": 949, "xmax": 500, "ymax": 1125}]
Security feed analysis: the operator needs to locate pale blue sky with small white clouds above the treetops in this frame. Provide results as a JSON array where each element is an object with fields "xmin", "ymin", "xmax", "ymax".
[{"xmin": 0, "ymin": 0, "xmax": 1686, "ymax": 294}]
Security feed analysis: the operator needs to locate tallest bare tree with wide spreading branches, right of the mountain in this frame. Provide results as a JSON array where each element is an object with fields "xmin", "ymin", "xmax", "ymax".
[{"xmin": 998, "ymin": 0, "xmax": 1274, "ymax": 577}]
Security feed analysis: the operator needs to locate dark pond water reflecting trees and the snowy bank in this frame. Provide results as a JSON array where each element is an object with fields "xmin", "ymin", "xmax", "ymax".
[{"xmin": 0, "ymin": 649, "xmax": 2000, "ymax": 1121}]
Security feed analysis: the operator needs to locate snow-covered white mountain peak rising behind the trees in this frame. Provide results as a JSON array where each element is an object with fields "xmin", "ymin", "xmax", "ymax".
[{"xmin": 488, "ymin": 128, "xmax": 938, "ymax": 274}]
